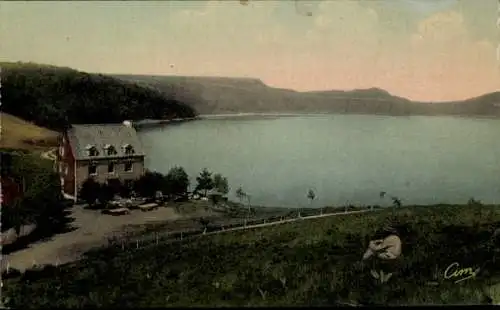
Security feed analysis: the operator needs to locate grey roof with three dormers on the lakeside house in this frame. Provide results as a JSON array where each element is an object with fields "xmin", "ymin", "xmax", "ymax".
[{"xmin": 68, "ymin": 124, "xmax": 145, "ymax": 159}]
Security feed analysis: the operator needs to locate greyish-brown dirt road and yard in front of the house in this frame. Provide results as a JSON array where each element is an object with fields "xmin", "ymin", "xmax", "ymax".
[{"xmin": 1, "ymin": 206, "xmax": 213, "ymax": 271}]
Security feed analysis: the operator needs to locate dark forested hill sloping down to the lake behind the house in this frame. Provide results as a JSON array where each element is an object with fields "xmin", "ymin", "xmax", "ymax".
[{"xmin": 0, "ymin": 62, "xmax": 196, "ymax": 130}]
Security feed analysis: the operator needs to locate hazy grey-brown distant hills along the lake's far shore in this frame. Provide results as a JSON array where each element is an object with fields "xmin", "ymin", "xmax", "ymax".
[{"xmin": 113, "ymin": 75, "xmax": 500, "ymax": 117}]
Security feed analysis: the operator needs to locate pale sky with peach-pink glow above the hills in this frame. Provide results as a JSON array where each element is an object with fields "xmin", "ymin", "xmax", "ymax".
[{"xmin": 0, "ymin": 0, "xmax": 500, "ymax": 102}]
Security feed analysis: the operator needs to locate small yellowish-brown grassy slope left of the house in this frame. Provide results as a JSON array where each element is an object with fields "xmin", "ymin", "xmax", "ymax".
[{"xmin": 0, "ymin": 113, "xmax": 57, "ymax": 151}]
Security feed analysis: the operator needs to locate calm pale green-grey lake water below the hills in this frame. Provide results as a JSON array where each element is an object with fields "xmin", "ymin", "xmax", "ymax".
[{"xmin": 140, "ymin": 115, "xmax": 500, "ymax": 207}]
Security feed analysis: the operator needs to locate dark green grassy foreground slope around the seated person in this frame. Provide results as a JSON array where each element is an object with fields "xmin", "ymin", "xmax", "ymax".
[{"xmin": 3, "ymin": 204, "xmax": 500, "ymax": 308}]
